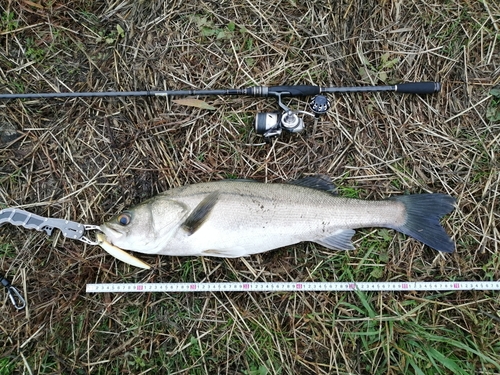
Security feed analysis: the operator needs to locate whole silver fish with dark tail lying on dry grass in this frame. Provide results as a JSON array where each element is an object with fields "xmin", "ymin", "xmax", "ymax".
[{"xmin": 101, "ymin": 176, "xmax": 455, "ymax": 258}]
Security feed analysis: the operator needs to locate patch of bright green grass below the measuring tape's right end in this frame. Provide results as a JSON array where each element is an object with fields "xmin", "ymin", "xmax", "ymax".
[{"xmin": 345, "ymin": 293, "xmax": 500, "ymax": 374}]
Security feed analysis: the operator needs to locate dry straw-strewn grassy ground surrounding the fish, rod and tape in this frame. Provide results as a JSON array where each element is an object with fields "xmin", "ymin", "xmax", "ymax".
[{"xmin": 0, "ymin": 0, "xmax": 500, "ymax": 375}]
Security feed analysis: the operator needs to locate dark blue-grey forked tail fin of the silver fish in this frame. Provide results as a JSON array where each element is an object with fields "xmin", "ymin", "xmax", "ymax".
[{"xmin": 390, "ymin": 194, "xmax": 455, "ymax": 253}]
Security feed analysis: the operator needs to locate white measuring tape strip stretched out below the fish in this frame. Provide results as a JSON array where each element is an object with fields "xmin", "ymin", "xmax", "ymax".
[{"xmin": 86, "ymin": 281, "xmax": 500, "ymax": 293}]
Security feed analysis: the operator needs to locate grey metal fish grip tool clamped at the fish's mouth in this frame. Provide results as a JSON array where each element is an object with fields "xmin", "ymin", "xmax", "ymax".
[{"xmin": 0, "ymin": 208, "xmax": 100, "ymax": 245}]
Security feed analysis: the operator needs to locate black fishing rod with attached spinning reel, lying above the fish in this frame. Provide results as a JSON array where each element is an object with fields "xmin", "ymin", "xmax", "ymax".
[{"xmin": 0, "ymin": 82, "xmax": 441, "ymax": 141}]
